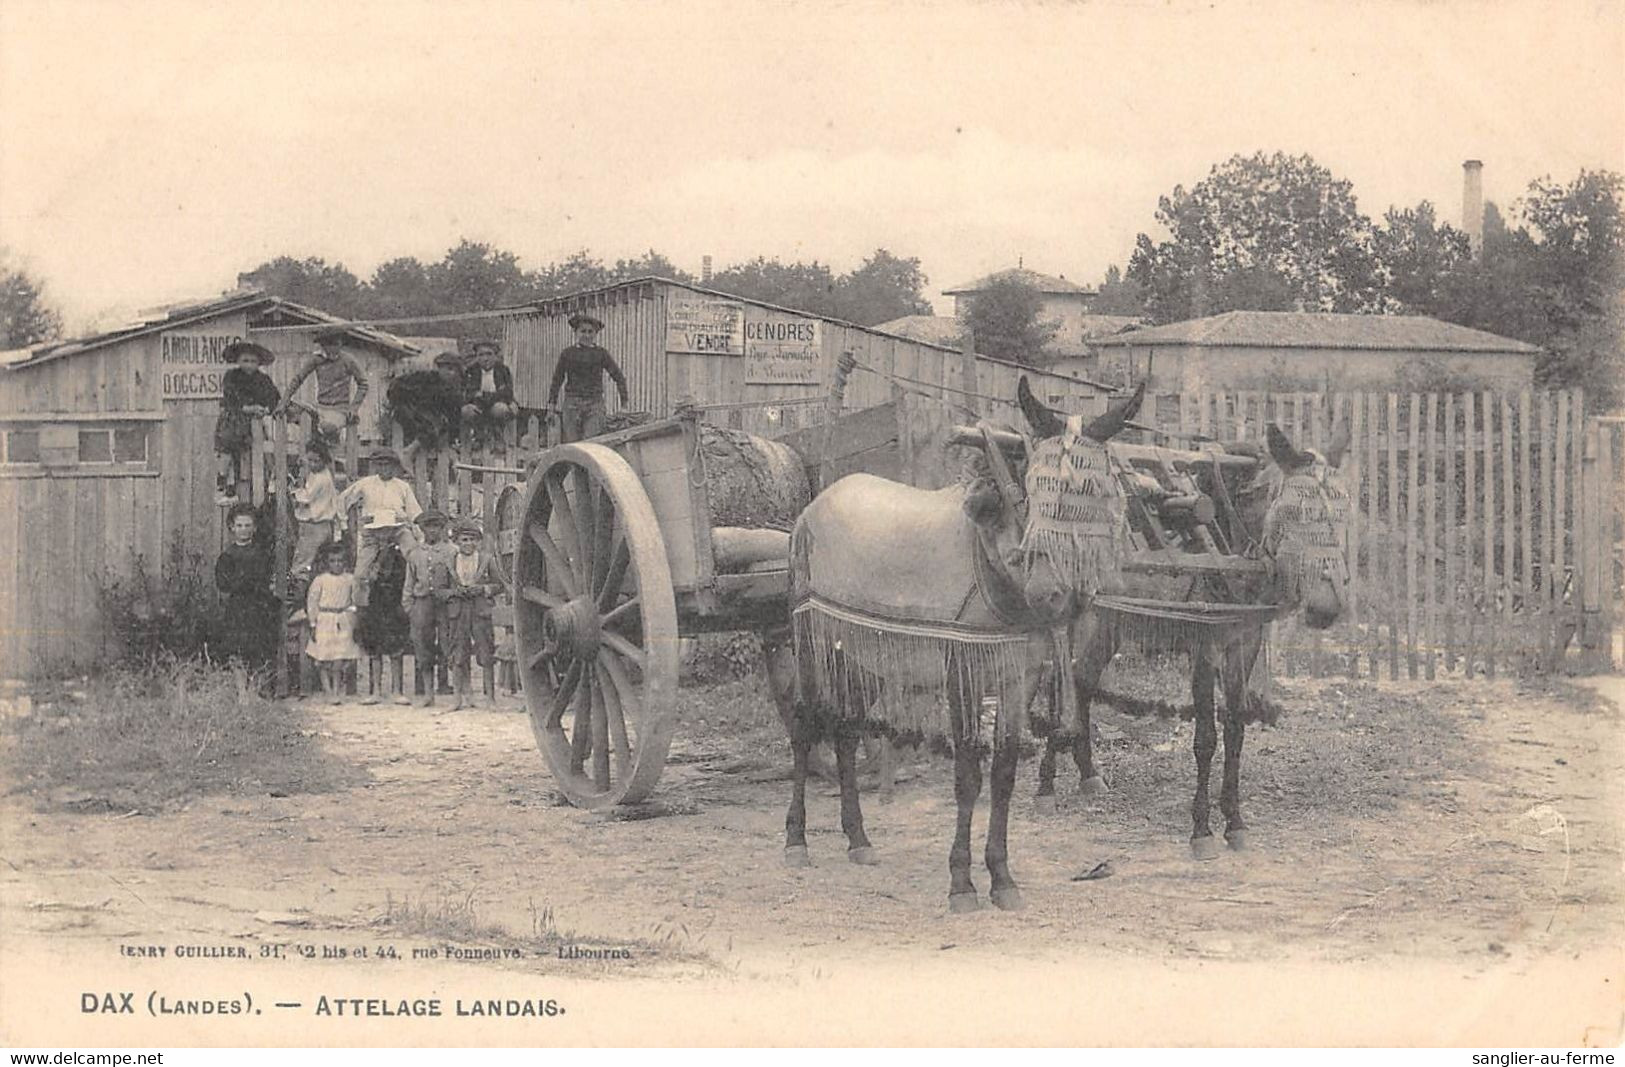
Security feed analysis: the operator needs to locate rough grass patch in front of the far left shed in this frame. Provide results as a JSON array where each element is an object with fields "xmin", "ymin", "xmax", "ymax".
[{"xmin": 0, "ymin": 658, "xmax": 362, "ymax": 814}]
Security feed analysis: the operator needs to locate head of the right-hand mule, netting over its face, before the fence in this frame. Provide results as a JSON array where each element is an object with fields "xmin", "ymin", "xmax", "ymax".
[{"xmin": 1240, "ymin": 426, "xmax": 1352, "ymax": 630}]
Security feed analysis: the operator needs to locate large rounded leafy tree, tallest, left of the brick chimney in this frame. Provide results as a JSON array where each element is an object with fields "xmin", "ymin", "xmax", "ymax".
[{"xmin": 1128, "ymin": 153, "xmax": 1380, "ymax": 322}]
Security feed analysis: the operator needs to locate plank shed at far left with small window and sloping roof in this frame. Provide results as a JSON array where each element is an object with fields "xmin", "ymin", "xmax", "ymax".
[{"xmin": 0, "ymin": 289, "xmax": 416, "ymax": 677}]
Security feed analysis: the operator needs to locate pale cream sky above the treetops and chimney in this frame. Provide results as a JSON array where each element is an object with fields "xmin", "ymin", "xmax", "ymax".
[{"xmin": 0, "ymin": 0, "xmax": 1625, "ymax": 328}]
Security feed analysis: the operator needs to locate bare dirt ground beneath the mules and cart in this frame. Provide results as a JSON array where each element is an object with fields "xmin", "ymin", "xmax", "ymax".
[{"xmin": 0, "ymin": 665, "xmax": 1625, "ymax": 1043}]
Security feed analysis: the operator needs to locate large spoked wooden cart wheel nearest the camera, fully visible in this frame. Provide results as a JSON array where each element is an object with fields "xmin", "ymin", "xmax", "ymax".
[{"xmin": 514, "ymin": 442, "xmax": 678, "ymax": 809}]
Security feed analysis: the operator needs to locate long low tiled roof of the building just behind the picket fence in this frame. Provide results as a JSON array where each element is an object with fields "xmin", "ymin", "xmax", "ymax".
[{"xmin": 1094, "ymin": 312, "xmax": 1541, "ymax": 356}]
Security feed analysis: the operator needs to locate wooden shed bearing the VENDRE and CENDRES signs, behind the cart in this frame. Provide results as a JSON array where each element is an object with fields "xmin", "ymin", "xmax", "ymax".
[{"xmin": 504, "ymin": 278, "xmax": 1124, "ymax": 435}]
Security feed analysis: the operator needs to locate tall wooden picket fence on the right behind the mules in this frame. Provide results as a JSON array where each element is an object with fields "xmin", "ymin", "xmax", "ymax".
[{"xmin": 1141, "ymin": 391, "xmax": 1625, "ymax": 679}]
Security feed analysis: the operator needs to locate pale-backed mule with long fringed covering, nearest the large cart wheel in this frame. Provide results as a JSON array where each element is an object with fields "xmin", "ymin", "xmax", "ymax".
[{"xmin": 765, "ymin": 380, "xmax": 1144, "ymax": 911}]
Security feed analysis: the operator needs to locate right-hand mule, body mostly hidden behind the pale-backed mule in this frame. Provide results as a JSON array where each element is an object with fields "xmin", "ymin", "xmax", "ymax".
[{"xmin": 1021, "ymin": 383, "xmax": 1350, "ymax": 859}]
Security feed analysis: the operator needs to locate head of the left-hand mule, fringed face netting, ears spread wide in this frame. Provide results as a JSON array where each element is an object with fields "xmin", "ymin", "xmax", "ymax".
[{"xmin": 1016, "ymin": 377, "xmax": 1146, "ymax": 619}]
